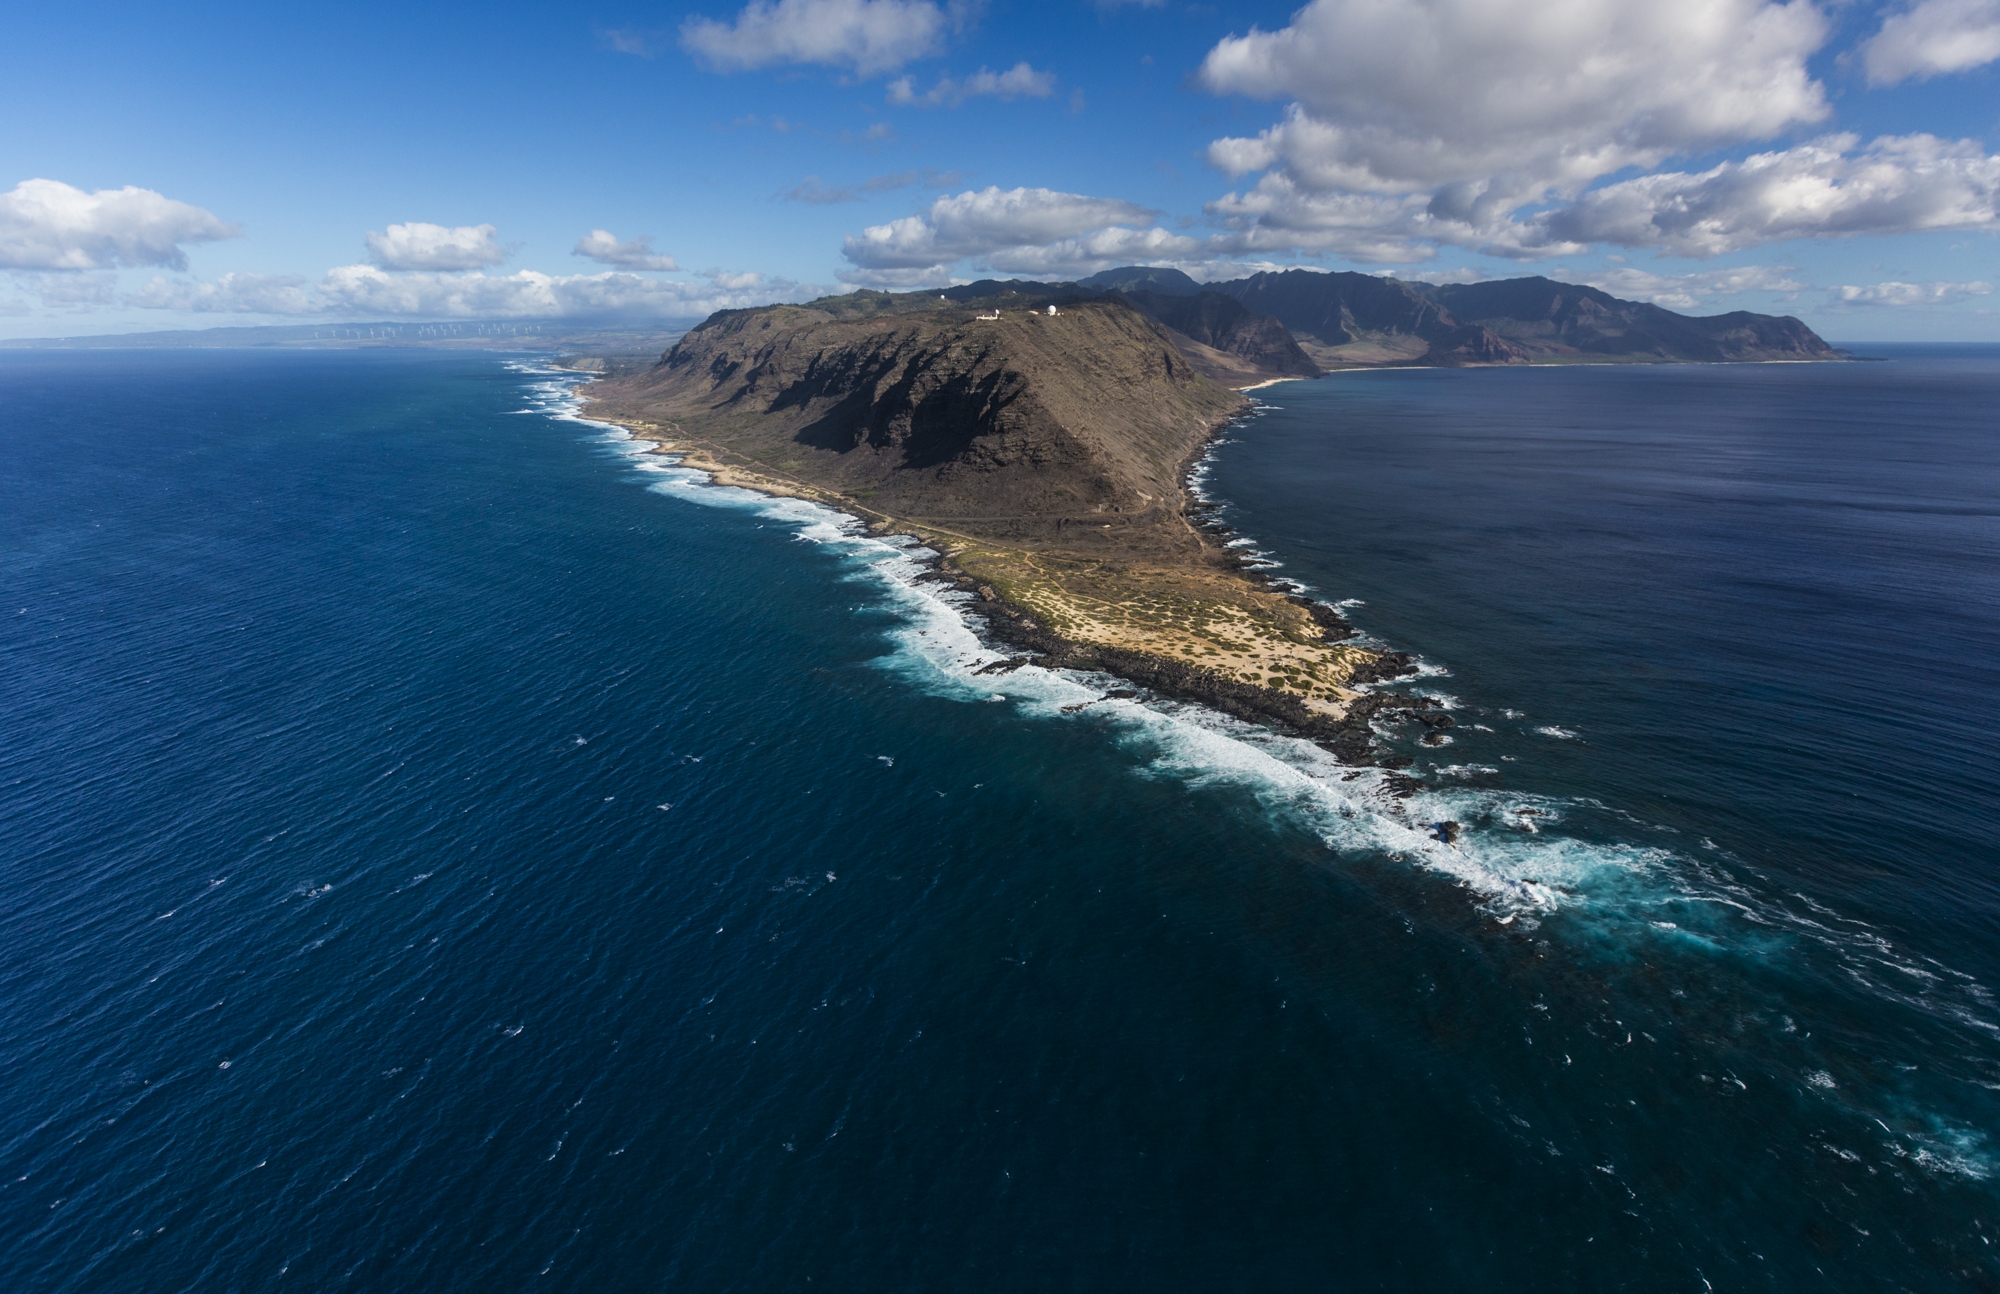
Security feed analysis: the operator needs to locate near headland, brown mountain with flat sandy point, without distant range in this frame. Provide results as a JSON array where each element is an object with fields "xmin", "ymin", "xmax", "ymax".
[{"xmin": 584, "ymin": 294, "xmax": 1400, "ymax": 744}]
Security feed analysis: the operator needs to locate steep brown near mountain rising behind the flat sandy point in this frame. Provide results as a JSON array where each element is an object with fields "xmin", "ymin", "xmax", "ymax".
[{"xmin": 592, "ymin": 292, "xmax": 1244, "ymax": 546}]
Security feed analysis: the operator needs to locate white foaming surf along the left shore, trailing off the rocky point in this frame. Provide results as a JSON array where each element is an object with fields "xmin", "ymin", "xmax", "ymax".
[{"xmin": 512, "ymin": 364, "xmax": 2000, "ymax": 1178}]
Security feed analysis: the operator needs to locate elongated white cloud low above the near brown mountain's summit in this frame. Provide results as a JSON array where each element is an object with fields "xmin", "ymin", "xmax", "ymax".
[{"xmin": 842, "ymin": 186, "xmax": 1156, "ymax": 282}]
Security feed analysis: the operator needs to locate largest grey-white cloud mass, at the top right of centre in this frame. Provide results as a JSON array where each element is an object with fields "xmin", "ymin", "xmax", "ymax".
[{"xmin": 1200, "ymin": 0, "xmax": 1830, "ymax": 260}]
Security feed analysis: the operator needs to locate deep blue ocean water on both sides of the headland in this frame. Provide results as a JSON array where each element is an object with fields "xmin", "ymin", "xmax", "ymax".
[{"xmin": 0, "ymin": 348, "xmax": 2000, "ymax": 1290}]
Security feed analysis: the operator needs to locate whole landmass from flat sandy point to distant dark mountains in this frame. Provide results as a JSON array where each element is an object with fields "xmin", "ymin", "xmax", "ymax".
[{"xmin": 586, "ymin": 270, "xmax": 1836, "ymax": 760}]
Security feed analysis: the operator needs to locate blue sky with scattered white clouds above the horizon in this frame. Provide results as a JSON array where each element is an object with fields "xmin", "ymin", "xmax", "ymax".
[{"xmin": 0, "ymin": 0, "xmax": 2000, "ymax": 342}]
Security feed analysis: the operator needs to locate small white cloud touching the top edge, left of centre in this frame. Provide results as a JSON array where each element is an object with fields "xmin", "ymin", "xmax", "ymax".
[{"xmin": 680, "ymin": 0, "xmax": 958, "ymax": 76}]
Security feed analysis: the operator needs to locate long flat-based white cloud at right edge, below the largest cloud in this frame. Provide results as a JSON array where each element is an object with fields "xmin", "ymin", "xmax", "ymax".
[{"xmin": 1522, "ymin": 134, "xmax": 2000, "ymax": 256}]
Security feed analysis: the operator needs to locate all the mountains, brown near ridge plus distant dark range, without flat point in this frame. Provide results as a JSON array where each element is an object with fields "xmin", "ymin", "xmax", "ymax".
[{"xmin": 596, "ymin": 270, "xmax": 1836, "ymax": 546}]
